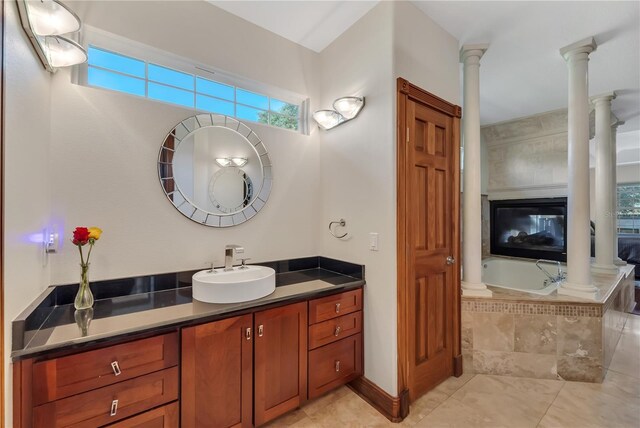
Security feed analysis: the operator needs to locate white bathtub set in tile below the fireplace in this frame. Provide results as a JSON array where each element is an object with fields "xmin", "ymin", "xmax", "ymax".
[{"xmin": 482, "ymin": 257, "xmax": 566, "ymax": 296}]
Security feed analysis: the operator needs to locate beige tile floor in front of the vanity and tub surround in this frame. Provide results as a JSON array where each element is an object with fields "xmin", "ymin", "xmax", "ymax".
[{"xmin": 269, "ymin": 315, "xmax": 640, "ymax": 428}]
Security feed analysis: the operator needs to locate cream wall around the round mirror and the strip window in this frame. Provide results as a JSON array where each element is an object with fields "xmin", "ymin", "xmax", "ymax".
[{"xmin": 46, "ymin": 1, "xmax": 320, "ymax": 284}]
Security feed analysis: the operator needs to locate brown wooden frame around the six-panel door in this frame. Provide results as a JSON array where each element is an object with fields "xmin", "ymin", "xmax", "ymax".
[{"xmin": 396, "ymin": 77, "xmax": 462, "ymax": 395}]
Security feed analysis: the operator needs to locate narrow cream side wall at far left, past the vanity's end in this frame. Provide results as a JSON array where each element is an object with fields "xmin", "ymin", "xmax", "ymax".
[{"xmin": 3, "ymin": 2, "xmax": 51, "ymax": 426}]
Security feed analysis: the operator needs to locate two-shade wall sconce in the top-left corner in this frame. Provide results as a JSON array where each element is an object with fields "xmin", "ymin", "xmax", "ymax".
[{"xmin": 18, "ymin": 0, "xmax": 87, "ymax": 73}]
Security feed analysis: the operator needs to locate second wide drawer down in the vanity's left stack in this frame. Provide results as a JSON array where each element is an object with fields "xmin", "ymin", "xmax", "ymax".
[{"xmin": 33, "ymin": 367, "xmax": 178, "ymax": 428}]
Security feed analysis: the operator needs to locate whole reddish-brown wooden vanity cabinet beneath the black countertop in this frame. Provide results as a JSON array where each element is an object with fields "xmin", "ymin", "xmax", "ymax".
[{"xmin": 14, "ymin": 289, "xmax": 362, "ymax": 428}]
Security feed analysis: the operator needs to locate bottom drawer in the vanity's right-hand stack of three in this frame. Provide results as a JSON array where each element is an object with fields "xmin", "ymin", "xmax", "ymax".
[{"xmin": 309, "ymin": 333, "xmax": 362, "ymax": 399}]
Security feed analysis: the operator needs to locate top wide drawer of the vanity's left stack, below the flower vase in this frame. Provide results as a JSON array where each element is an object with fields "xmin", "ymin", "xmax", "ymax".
[{"xmin": 33, "ymin": 333, "xmax": 178, "ymax": 406}]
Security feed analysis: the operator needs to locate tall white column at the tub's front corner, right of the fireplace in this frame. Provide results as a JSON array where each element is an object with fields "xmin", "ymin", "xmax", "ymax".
[{"xmin": 558, "ymin": 37, "xmax": 598, "ymax": 300}]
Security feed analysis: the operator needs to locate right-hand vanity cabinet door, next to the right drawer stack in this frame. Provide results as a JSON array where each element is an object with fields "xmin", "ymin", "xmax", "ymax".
[{"xmin": 255, "ymin": 302, "xmax": 307, "ymax": 426}]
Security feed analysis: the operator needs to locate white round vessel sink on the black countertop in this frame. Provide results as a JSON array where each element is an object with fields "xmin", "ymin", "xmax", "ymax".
[{"xmin": 192, "ymin": 266, "xmax": 276, "ymax": 303}]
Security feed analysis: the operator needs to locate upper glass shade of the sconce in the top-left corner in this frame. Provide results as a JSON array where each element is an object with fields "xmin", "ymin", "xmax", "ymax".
[{"xmin": 25, "ymin": 0, "xmax": 80, "ymax": 36}]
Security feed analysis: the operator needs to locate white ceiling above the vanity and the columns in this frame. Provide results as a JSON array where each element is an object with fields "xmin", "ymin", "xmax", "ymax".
[{"xmin": 210, "ymin": 1, "xmax": 640, "ymax": 135}]
